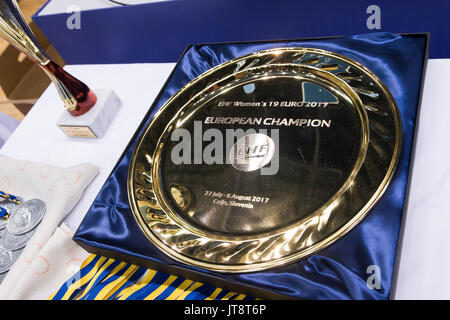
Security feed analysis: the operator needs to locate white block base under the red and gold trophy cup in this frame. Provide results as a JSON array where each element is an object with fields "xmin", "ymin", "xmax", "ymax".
[{"xmin": 56, "ymin": 89, "xmax": 122, "ymax": 138}]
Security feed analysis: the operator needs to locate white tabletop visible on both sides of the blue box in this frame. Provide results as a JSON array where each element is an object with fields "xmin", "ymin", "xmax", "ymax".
[{"xmin": 0, "ymin": 59, "xmax": 450, "ymax": 299}]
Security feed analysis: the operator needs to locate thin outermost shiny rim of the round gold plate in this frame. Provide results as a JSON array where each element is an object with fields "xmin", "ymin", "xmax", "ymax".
[{"xmin": 127, "ymin": 47, "xmax": 402, "ymax": 273}]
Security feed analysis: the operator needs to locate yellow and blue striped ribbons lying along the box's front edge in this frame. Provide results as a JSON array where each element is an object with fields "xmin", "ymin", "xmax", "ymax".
[{"xmin": 49, "ymin": 255, "xmax": 254, "ymax": 300}]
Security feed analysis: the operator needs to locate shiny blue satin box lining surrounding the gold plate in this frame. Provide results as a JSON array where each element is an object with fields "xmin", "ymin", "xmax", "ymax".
[{"xmin": 74, "ymin": 33, "xmax": 426, "ymax": 299}]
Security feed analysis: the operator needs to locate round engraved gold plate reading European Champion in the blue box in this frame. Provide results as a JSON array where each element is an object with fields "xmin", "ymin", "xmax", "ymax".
[{"xmin": 128, "ymin": 48, "xmax": 401, "ymax": 272}]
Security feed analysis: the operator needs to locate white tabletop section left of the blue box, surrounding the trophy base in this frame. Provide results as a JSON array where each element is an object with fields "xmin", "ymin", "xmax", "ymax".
[{"xmin": 0, "ymin": 63, "xmax": 175, "ymax": 230}]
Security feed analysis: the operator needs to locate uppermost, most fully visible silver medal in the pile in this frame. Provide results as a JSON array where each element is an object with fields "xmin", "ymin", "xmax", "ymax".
[{"xmin": 7, "ymin": 199, "xmax": 45, "ymax": 235}]
